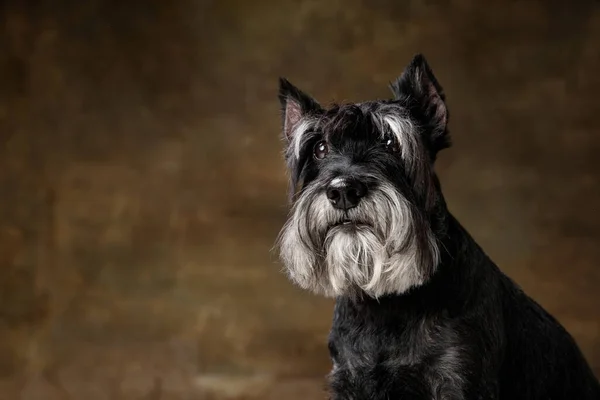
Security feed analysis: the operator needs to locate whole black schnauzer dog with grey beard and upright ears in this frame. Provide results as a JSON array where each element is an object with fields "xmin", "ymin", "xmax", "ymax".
[{"xmin": 275, "ymin": 54, "xmax": 600, "ymax": 400}]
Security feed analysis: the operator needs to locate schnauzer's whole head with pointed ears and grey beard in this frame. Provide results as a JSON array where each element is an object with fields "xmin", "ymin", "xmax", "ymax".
[{"xmin": 278, "ymin": 55, "xmax": 449, "ymax": 297}]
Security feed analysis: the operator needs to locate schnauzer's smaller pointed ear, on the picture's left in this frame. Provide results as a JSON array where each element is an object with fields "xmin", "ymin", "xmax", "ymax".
[{"xmin": 279, "ymin": 78, "xmax": 321, "ymax": 141}]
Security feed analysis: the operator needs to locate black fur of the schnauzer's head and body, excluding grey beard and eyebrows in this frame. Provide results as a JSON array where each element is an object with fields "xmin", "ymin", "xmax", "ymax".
[{"xmin": 280, "ymin": 55, "xmax": 600, "ymax": 400}]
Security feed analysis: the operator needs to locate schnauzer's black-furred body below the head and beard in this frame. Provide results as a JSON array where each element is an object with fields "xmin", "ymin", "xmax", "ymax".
[{"xmin": 329, "ymin": 215, "xmax": 600, "ymax": 400}]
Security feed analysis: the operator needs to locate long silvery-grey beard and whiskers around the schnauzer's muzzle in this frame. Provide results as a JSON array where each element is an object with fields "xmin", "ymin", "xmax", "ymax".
[{"xmin": 279, "ymin": 183, "xmax": 439, "ymax": 298}]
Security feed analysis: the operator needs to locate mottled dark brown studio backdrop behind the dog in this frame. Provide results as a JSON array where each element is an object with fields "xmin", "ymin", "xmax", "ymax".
[{"xmin": 0, "ymin": 0, "xmax": 600, "ymax": 400}]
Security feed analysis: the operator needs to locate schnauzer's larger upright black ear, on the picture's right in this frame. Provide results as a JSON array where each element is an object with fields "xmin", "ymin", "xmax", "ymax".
[{"xmin": 390, "ymin": 54, "xmax": 450, "ymax": 155}]
